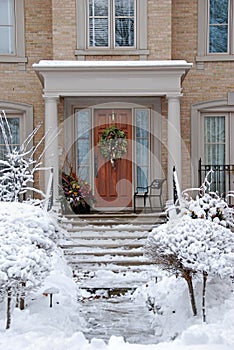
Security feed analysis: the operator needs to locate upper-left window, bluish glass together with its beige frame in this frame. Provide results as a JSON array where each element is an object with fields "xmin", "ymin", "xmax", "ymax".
[{"xmin": 0, "ymin": 0, "xmax": 27, "ymax": 63}]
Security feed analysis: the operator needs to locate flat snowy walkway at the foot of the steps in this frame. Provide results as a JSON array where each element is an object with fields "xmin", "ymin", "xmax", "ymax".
[{"xmin": 77, "ymin": 284, "xmax": 157, "ymax": 344}]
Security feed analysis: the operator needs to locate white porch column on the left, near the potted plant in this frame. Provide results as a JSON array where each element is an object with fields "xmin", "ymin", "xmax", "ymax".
[{"xmin": 43, "ymin": 96, "xmax": 59, "ymax": 203}]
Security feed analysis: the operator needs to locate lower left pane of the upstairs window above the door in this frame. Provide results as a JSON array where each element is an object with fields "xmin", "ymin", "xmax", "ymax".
[{"xmin": 89, "ymin": 18, "xmax": 108, "ymax": 47}]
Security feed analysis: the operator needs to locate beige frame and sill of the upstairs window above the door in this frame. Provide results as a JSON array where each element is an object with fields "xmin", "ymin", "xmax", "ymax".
[{"xmin": 75, "ymin": 0, "xmax": 149, "ymax": 60}]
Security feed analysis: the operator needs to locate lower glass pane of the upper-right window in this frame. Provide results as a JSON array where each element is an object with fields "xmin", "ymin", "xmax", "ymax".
[{"xmin": 209, "ymin": 26, "xmax": 228, "ymax": 53}]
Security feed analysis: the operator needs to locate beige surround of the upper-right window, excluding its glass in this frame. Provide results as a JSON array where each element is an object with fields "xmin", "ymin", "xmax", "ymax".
[{"xmin": 196, "ymin": 0, "xmax": 234, "ymax": 63}]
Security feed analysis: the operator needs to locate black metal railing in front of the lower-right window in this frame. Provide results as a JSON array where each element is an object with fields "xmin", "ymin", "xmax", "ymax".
[{"xmin": 198, "ymin": 159, "xmax": 234, "ymax": 202}]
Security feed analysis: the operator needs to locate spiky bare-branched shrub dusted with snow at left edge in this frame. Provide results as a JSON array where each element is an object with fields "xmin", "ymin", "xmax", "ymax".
[{"xmin": 0, "ymin": 111, "xmax": 45, "ymax": 202}]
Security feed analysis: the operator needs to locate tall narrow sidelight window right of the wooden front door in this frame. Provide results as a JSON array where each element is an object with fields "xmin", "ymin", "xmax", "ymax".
[{"xmin": 136, "ymin": 109, "xmax": 149, "ymax": 187}]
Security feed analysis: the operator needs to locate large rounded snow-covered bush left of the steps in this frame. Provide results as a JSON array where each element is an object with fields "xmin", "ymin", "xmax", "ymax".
[{"xmin": 0, "ymin": 202, "xmax": 58, "ymax": 328}]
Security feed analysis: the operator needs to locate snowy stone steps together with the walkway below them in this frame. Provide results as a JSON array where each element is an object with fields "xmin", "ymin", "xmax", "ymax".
[{"xmin": 60, "ymin": 216, "xmax": 165, "ymax": 344}]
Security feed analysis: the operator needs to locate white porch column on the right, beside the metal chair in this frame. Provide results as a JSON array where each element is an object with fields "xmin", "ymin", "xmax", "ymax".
[{"xmin": 167, "ymin": 95, "xmax": 182, "ymax": 200}]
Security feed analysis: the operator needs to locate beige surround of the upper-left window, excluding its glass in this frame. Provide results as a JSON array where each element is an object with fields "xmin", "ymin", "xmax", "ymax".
[{"xmin": 0, "ymin": 0, "xmax": 27, "ymax": 69}]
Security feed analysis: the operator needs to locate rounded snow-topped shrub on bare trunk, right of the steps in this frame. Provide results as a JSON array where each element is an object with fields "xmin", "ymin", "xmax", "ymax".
[{"xmin": 145, "ymin": 216, "xmax": 234, "ymax": 315}]
